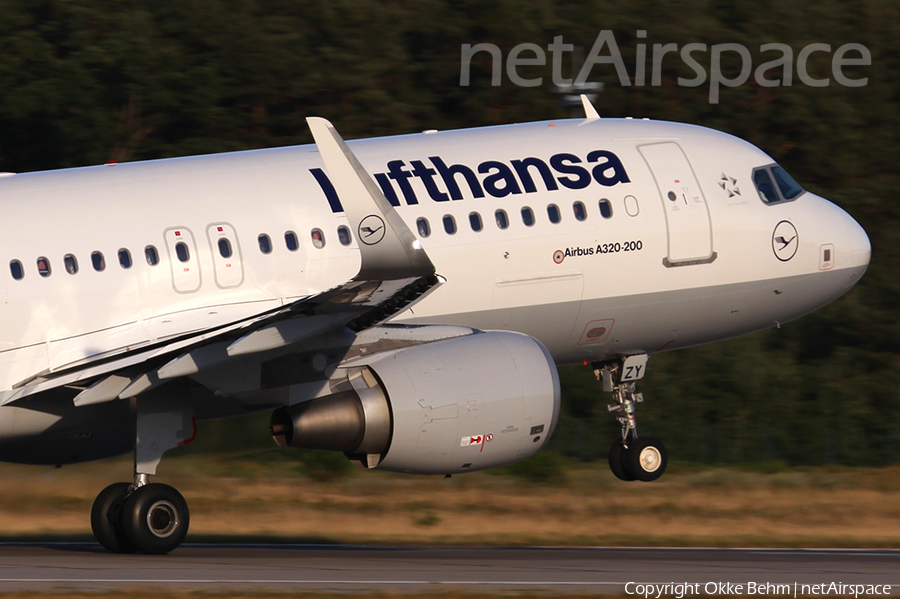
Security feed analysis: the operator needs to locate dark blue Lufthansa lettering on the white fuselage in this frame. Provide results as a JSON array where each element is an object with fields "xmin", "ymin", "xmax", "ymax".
[{"xmin": 309, "ymin": 150, "xmax": 631, "ymax": 212}]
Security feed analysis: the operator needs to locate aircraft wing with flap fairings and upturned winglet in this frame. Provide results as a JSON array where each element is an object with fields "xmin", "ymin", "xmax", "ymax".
[{"xmin": 0, "ymin": 117, "xmax": 440, "ymax": 405}]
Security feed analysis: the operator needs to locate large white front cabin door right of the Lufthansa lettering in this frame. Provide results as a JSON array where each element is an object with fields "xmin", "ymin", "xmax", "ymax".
[{"xmin": 638, "ymin": 142, "xmax": 714, "ymax": 266}]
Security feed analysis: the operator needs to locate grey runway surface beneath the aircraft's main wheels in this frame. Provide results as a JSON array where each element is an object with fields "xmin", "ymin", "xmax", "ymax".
[{"xmin": 0, "ymin": 543, "xmax": 900, "ymax": 594}]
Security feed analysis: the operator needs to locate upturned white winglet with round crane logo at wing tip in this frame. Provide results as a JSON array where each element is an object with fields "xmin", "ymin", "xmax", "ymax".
[{"xmin": 306, "ymin": 117, "xmax": 434, "ymax": 280}]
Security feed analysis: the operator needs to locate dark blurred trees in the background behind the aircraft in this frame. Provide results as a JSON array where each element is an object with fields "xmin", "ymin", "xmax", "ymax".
[{"xmin": 0, "ymin": 0, "xmax": 900, "ymax": 465}]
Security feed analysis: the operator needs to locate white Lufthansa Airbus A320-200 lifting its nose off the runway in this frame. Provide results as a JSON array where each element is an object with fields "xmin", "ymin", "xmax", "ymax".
[{"xmin": 0, "ymin": 102, "xmax": 870, "ymax": 553}]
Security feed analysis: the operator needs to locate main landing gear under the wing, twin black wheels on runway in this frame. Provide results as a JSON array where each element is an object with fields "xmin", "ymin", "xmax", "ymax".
[{"xmin": 91, "ymin": 396, "xmax": 195, "ymax": 554}]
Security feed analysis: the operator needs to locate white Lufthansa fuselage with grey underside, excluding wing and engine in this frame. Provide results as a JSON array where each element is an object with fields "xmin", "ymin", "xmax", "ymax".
[{"xmin": 0, "ymin": 119, "xmax": 870, "ymax": 398}]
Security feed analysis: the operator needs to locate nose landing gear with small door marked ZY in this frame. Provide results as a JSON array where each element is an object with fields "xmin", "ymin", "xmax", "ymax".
[{"xmin": 591, "ymin": 354, "xmax": 669, "ymax": 481}]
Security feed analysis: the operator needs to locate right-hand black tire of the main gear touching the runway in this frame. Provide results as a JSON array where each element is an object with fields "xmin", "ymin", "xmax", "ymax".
[{"xmin": 122, "ymin": 483, "xmax": 191, "ymax": 555}]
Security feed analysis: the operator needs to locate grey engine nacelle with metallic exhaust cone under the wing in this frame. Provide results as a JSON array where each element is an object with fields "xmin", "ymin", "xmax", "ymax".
[{"xmin": 272, "ymin": 331, "xmax": 560, "ymax": 474}]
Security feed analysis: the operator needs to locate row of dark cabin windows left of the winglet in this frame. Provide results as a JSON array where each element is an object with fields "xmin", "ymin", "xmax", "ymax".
[{"xmin": 9, "ymin": 225, "xmax": 352, "ymax": 281}]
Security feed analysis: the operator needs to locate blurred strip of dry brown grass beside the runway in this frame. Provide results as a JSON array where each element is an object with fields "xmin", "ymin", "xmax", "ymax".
[{"xmin": 0, "ymin": 450, "xmax": 900, "ymax": 548}]
